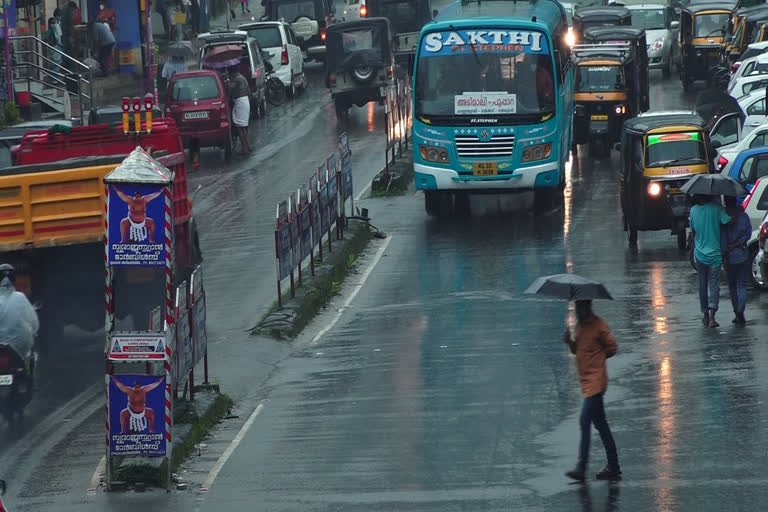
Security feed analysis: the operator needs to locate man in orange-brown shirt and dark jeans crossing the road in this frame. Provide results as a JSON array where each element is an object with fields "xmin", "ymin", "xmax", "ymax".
[{"xmin": 563, "ymin": 300, "xmax": 621, "ymax": 481}]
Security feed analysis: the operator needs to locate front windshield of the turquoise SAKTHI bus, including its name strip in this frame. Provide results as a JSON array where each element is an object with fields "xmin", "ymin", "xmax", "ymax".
[{"xmin": 415, "ymin": 30, "xmax": 555, "ymax": 116}]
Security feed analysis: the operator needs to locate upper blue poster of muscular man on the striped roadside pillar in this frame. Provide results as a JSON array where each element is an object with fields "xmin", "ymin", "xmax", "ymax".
[{"xmin": 108, "ymin": 184, "xmax": 165, "ymax": 267}]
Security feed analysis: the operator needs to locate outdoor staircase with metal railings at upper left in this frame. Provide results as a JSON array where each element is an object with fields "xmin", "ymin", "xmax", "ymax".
[{"xmin": 11, "ymin": 36, "xmax": 93, "ymax": 124}]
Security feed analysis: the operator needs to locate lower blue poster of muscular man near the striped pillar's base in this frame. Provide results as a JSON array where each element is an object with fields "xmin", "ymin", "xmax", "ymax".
[{"xmin": 109, "ymin": 375, "xmax": 166, "ymax": 457}]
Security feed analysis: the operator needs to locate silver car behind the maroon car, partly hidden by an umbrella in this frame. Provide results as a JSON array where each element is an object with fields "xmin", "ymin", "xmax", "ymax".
[{"xmin": 197, "ymin": 30, "xmax": 267, "ymax": 117}]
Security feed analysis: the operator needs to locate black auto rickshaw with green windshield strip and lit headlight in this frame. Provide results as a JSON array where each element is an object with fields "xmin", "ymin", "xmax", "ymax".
[{"xmin": 619, "ymin": 111, "xmax": 712, "ymax": 250}]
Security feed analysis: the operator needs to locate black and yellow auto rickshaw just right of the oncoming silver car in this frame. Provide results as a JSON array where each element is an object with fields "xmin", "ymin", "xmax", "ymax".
[{"xmin": 680, "ymin": 4, "xmax": 731, "ymax": 91}]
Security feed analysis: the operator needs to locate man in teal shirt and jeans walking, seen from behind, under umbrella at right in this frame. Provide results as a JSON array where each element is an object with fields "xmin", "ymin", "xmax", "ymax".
[{"xmin": 690, "ymin": 195, "xmax": 731, "ymax": 328}]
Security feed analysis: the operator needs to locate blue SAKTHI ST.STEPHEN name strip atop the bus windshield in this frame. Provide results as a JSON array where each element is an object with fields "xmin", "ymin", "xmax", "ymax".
[{"xmin": 419, "ymin": 29, "xmax": 549, "ymax": 58}]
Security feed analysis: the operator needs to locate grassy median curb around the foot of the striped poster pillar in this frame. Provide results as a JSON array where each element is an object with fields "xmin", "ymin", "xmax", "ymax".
[{"xmin": 112, "ymin": 385, "xmax": 234, "ymax": 492}]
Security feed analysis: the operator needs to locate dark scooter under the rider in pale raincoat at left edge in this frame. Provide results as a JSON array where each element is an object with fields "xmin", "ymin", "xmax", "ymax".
[{"xmin": 0, "ymin": 342, "xmax": 37, "ymax": 422}]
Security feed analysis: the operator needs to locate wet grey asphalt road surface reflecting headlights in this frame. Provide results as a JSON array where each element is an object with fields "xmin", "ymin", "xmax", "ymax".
[{"xmin": 0, "ymin": 54, "xmax": 768, "ymax": 512}]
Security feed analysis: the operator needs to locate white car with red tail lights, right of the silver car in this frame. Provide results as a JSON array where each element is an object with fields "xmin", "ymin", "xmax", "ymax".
[{"xmin": 238, "ymin": 21, "xmax": 307, "ymax": 97}]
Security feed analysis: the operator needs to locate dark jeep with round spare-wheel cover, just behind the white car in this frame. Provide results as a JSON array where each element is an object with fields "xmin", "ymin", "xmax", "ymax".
[{"xmin": 262, "ymin": 0, "xmax": 336, "ymax": 61}]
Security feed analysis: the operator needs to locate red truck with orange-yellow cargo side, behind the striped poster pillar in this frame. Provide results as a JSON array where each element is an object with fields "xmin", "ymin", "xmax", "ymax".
[{"xmin": 0, "ymin": 118, "xmax": 202, "ymax": 340}]
